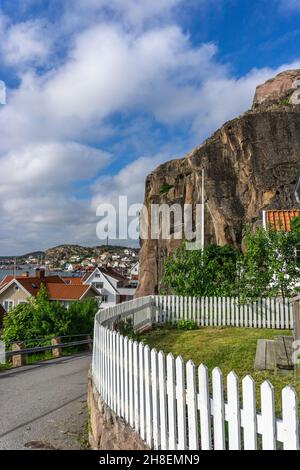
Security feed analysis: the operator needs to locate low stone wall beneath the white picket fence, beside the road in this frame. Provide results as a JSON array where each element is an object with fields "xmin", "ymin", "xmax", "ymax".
[{"xmin": 88, "ymin": 372, "xmax": 149, "ymax": 450}]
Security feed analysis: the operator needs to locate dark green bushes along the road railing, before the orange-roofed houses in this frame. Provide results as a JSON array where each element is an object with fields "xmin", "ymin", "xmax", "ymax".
[{"xmin": 3, "ymin": 285, "xmax": 99, "ymax": 344}]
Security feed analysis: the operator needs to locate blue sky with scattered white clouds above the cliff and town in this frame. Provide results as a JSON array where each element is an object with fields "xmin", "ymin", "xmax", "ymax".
[{"xmin": 0, "ymin": 0, "xmax": 300, "ymax": 255}]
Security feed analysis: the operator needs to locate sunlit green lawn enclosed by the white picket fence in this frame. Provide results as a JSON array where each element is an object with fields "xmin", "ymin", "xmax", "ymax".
[{"xmin": 141, "ymin": 327, "xmax": 300, "ymax": 415}]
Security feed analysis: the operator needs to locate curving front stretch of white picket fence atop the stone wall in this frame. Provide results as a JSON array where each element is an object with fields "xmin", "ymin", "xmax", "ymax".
[{"xmin": 92, "ymin": 297, "xmax": 299, "ymax": 450}]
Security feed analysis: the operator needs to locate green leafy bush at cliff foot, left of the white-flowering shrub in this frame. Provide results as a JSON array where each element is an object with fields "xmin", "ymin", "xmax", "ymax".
[{"xmin": 163, "ymin": 245, "xmax": 240, "ymax": 296}]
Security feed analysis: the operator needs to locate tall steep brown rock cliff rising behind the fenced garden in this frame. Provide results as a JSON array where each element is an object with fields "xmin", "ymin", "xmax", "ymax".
[{"xmin": 137, "ymin": 70, "xmax": 300, "ymax": 296}]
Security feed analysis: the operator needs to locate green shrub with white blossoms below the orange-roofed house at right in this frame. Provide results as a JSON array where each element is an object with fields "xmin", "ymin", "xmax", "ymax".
[{"xmin": 240, "ymin": 225, "xmax": 300, "ymax": 298}]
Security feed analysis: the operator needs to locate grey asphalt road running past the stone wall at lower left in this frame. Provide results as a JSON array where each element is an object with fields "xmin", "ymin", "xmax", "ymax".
[{"xmin": 0, "ymin": 353, "xmax": 91, "ymax": 449}]
